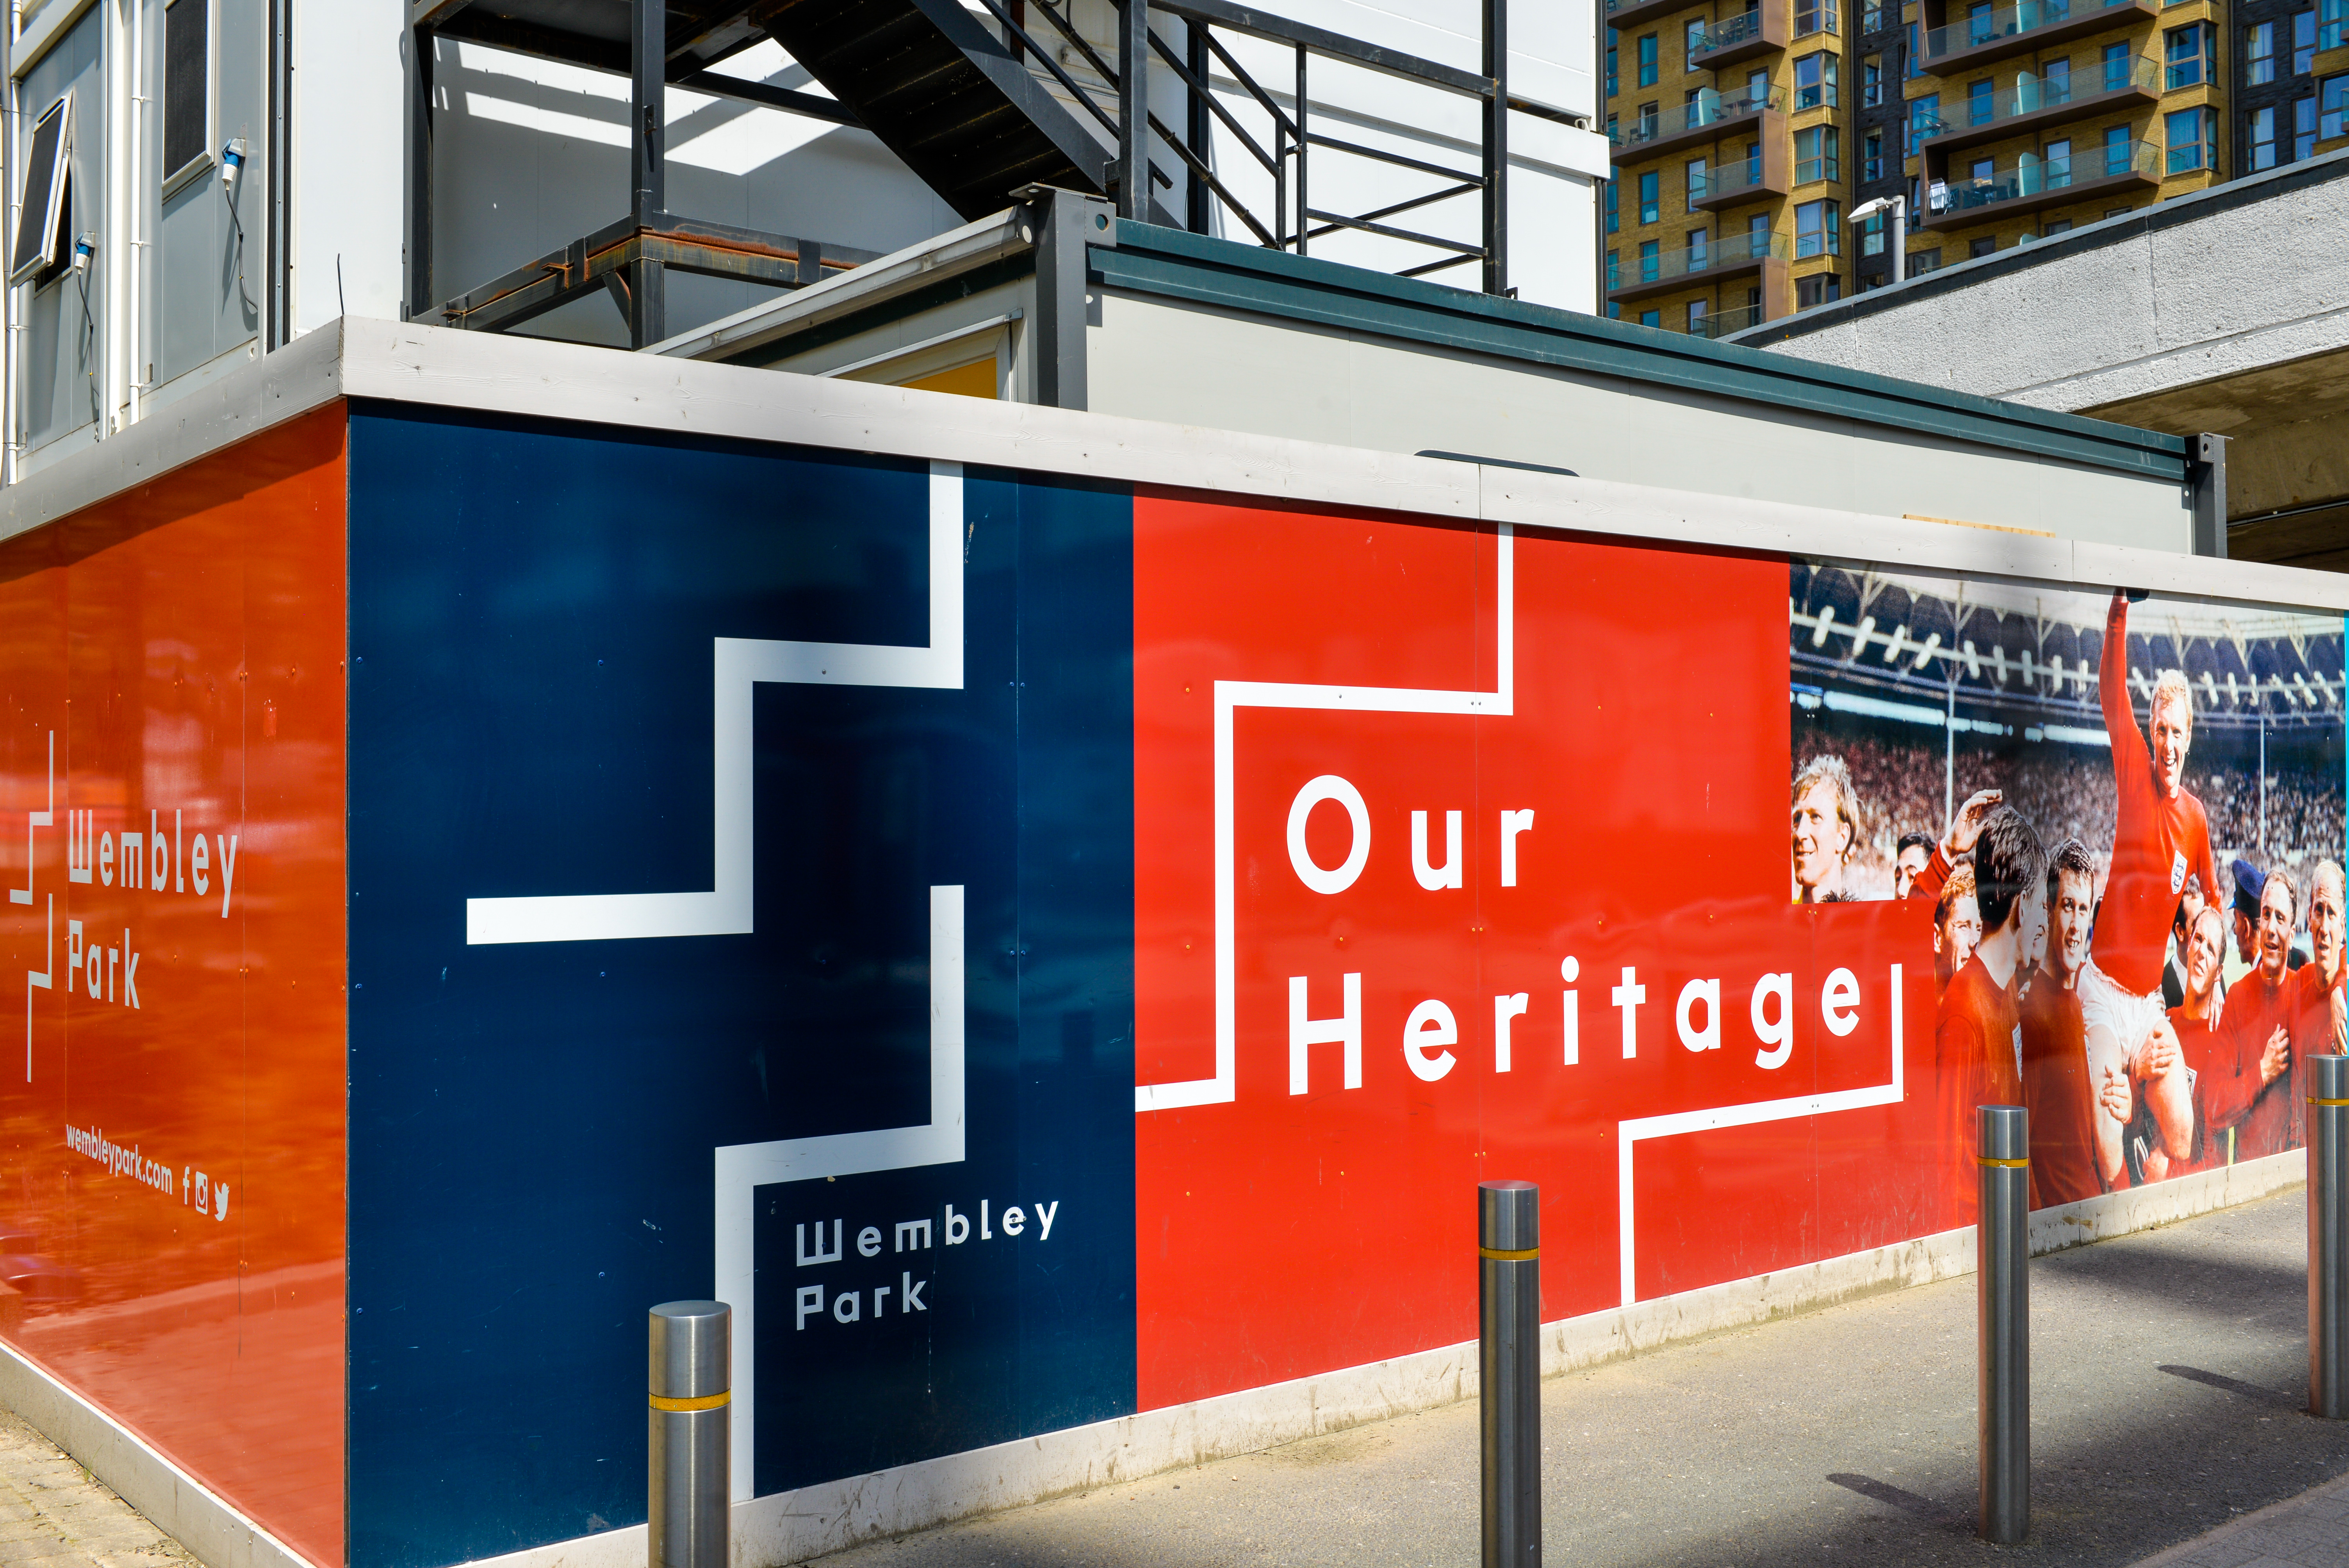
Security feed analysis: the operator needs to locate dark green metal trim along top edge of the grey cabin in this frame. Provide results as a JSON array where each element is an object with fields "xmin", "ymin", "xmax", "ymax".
[{"xmin": 1090, "ymin": 218, "xmax": 2187, "ymax": 483}]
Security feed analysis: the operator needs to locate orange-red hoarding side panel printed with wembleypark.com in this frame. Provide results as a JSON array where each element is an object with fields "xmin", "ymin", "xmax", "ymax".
[{"xmin": 0, "ymin": 406, "xmax": 345, "ymax": 1563}]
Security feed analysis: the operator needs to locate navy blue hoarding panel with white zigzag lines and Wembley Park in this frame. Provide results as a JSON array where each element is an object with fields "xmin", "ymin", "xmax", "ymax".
[{"xmin": 350, "ymin": 404, "xmax": 1135, "ymax": 1568}]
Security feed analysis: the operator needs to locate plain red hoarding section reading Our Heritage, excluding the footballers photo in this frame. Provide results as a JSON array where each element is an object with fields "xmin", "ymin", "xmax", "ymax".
[{"xmin": 1135, "ymin": 498, "xmax": 1938, "ymax": 1408}]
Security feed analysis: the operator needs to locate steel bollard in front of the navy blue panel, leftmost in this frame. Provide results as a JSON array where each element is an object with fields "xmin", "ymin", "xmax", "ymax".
[{"xmin": 646, "ymin": 1301, "xmax": 733, "ymax": 1568}]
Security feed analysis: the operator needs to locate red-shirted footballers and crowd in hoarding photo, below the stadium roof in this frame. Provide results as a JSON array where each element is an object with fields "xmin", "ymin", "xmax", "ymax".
[{"xmin": 1790, "ymin": 594, "xmax": 2349, "ymax": 1223}]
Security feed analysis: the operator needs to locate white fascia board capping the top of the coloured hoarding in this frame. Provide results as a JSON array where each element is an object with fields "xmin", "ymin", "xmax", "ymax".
[{"xmin": 18, "ymin": 319, "xmax": 2349, "ymax": 613}]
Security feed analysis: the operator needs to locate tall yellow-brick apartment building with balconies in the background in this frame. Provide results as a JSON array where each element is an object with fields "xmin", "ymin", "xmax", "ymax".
[{"xmin": 1602, "ymin": 0, "xmax": 2349, "ymax": 336}]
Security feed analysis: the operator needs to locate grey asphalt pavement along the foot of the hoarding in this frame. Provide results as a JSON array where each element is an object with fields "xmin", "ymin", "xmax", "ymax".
[{"xmin": 822, "ymin": 1192, "xmax": 2349, "ymax": 1568}]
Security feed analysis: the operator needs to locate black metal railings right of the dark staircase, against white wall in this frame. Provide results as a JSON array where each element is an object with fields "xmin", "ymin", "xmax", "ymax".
[{"xmin": 980, "ymin": 0, "xmax": 1550, "ymax": 293}]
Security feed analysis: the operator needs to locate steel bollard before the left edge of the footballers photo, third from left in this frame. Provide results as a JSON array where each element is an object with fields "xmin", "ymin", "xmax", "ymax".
[{"xmin": 1973, "ymin": 1106, "xmax": 2032, "ymax": 1547}]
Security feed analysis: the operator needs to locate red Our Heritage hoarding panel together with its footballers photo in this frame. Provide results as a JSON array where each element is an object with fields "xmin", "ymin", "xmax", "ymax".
[{"xmin": 1135, "ymin": 498, "xmax": 2344, "ymax": 1408}]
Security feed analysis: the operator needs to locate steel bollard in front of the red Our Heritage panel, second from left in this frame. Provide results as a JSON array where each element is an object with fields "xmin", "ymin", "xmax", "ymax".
[{"xmin": 1475, "ymin": 1181, "xmax": 1541, "ymax": 1568}]
